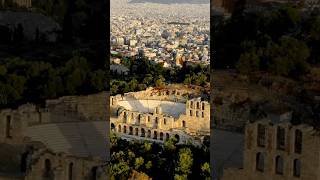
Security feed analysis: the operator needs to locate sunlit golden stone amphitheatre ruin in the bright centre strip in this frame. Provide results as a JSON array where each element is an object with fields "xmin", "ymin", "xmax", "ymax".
[{"xmin": 110, "ymin": 88, "xmax": 210, "ymax": 145}]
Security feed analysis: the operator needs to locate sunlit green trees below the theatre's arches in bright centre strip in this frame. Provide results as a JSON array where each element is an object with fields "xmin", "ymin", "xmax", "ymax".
[{"xmin": 110, "ymin": 134, "xmax": 210, "ymax": 180}]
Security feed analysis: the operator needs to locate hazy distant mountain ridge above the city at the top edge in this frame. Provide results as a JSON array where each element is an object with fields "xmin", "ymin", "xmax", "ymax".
[{"xmin": 128, "ymin": 0, "xmax": 210, "ymax": 4}]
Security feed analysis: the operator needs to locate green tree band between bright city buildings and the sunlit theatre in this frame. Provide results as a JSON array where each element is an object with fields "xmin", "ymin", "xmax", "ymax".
[{"xmin": 110, "ymin": 57, "xmax": 210, "ymax": 95}]
